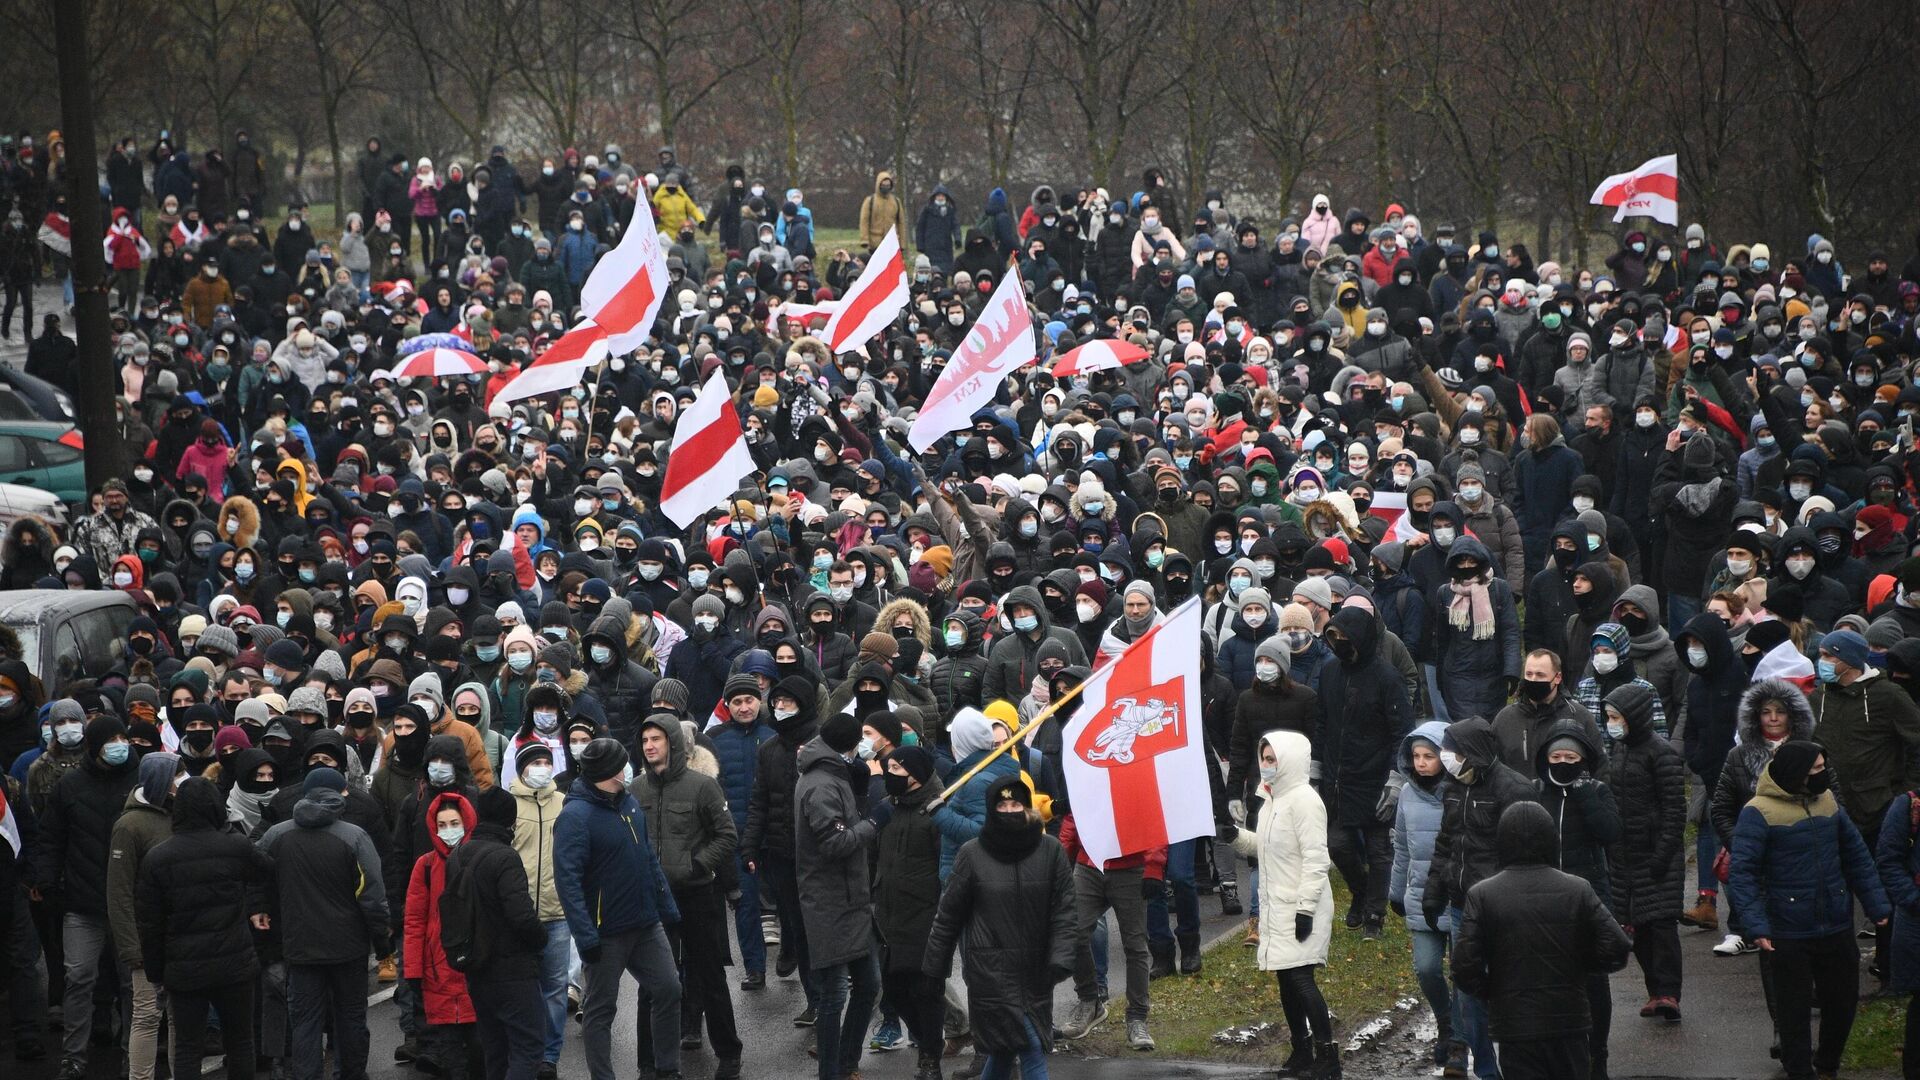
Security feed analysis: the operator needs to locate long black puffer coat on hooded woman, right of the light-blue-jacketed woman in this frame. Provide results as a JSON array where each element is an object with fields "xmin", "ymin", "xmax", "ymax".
[{"xmin": 1607, "ymin": 682, "xmax": 1686, "ymax": 926}]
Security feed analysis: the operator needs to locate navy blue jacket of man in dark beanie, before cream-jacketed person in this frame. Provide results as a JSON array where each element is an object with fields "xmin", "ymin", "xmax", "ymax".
[{"xmin": 553, "ymin": 778, "xmax": 680, "ymax": 953}]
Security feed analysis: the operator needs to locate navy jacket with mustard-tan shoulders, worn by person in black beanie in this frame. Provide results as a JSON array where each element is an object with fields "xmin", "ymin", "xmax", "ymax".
[{"xmin": 1726, "ymin": 763, "xmax": 1897, "ymax": 940}]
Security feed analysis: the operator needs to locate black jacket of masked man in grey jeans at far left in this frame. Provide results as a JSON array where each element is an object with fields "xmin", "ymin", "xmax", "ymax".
[{"xmin": 33, "ymin": 737, "xmax": 140, "ymax": 907}]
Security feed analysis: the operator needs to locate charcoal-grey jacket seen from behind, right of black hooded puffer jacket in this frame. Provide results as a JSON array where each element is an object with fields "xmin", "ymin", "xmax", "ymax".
[{"xmin": 255, "ymin": 780, "xmax": 394, "ymax": 965}]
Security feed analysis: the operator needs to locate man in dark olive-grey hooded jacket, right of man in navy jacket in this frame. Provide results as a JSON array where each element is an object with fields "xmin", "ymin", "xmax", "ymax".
[{"xmin": 630, "ymin": 713, "xmax": 741, "ymax": 1080}]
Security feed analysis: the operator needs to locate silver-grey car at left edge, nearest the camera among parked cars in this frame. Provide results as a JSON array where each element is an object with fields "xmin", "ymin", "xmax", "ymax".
[{"xmin": 0, "ymin": 588, "xmax": 138, "ymax": 696}]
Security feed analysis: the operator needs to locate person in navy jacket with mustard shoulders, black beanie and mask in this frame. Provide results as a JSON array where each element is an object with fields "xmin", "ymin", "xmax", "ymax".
[{"xmin": 1726, "ymin": 740, "xmax": 1905, "ymax": 1076}]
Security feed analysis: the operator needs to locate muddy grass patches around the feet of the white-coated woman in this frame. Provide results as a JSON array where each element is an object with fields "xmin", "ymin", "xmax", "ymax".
[{"xmin": 1073, "ymin": 878, "xmax": 1420, "ymax": 1065}]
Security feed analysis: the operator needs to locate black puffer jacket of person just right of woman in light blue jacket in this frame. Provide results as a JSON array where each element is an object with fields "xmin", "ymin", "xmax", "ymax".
[{"xmin": 1421, "ymin": 718, "xmax": 1536, "ymax": 910}]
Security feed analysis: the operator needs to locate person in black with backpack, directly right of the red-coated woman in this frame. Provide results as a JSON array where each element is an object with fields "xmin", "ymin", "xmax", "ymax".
[{"xmin": 447, "ymin": 788, "xmax": 547, "ymax": 1078}]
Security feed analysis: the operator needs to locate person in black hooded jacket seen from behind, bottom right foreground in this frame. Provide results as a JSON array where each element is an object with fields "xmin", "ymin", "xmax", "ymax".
[{"xmin": 1450, "ymin": 799, "xmax": 1630, "ymax": 1080}]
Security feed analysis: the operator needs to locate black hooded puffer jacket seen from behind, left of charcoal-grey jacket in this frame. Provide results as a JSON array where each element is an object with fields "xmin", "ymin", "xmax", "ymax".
[{"xmin": 134, "ymin": 778, "xmax": 273, "ymax": 990}]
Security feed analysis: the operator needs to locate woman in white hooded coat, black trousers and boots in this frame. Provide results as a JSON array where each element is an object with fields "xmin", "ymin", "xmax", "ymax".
[{"xmin": 1233, "ymin": 730, "xmax": 1340, "ymax": 1078}]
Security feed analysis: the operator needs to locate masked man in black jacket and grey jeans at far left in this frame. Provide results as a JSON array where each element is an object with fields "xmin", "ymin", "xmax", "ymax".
[{"xmin": 31, "ymin": 715, "xmax": 140, "ymax": 1078}]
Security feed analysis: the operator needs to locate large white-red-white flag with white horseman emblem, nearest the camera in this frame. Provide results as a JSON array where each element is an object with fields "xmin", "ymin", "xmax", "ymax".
[{"xmin": 1060, "ymin": 598, "xmax": 1213, "ymax": 867}]
